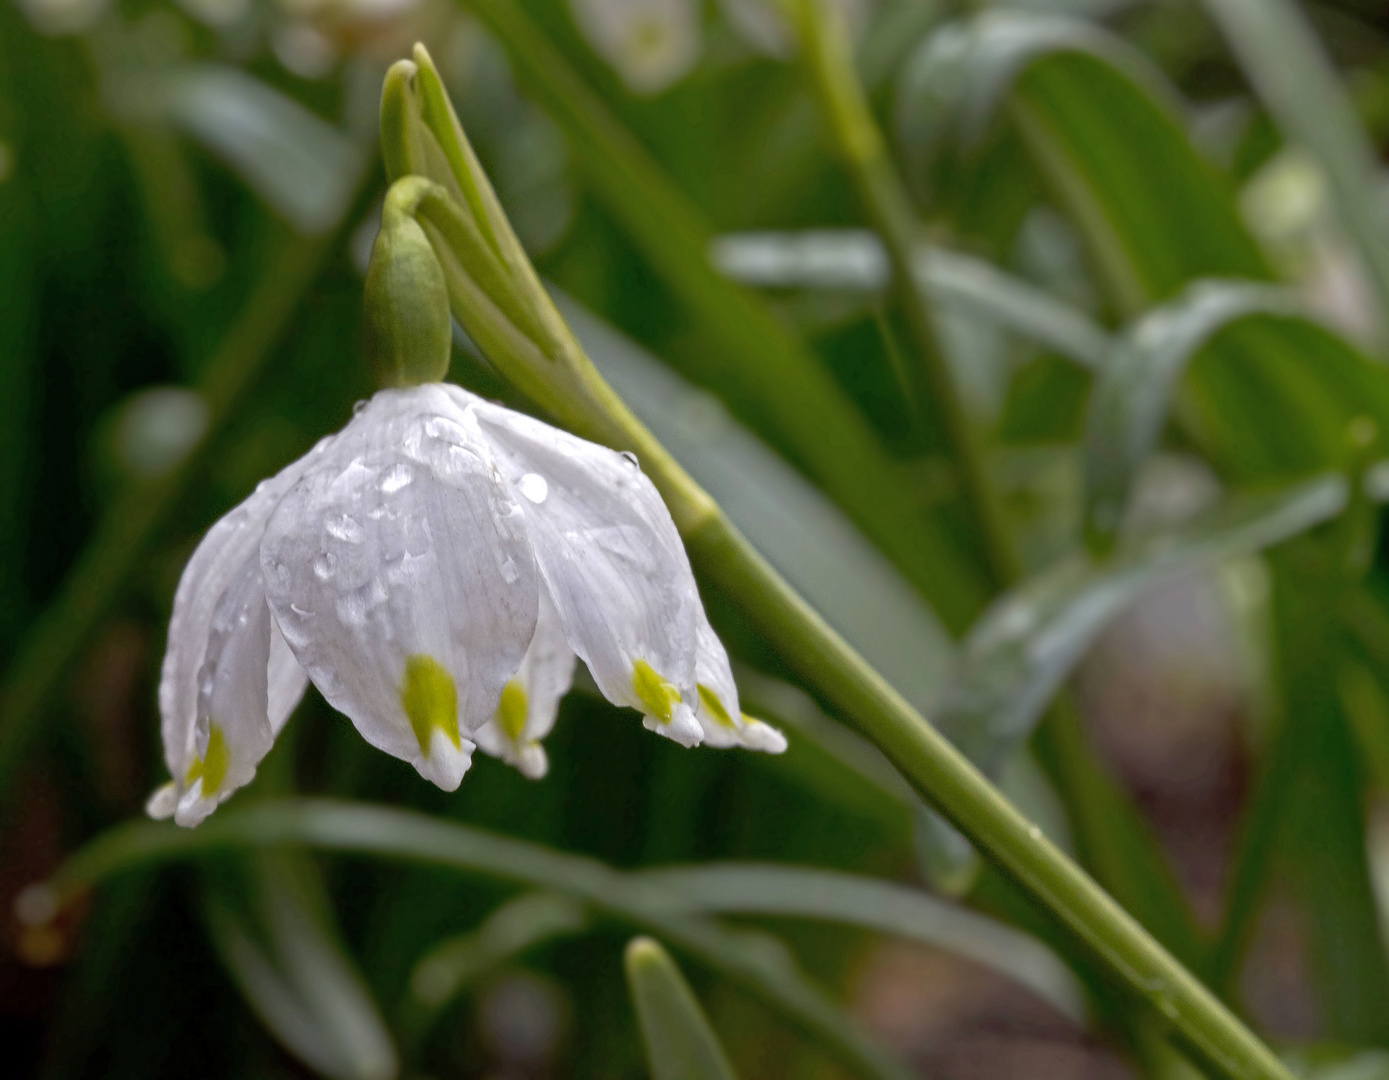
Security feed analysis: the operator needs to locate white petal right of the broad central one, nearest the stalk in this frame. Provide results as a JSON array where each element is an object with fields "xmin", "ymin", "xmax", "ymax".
[{"xmin": 469, "ymin": 398, "xmax": 700, "ymax": 730}]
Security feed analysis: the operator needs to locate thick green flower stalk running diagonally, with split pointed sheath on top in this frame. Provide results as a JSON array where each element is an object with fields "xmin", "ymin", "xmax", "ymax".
[{"xmin": 383, "ymin": 46, "xmax": 1289, "ymax": 1080}]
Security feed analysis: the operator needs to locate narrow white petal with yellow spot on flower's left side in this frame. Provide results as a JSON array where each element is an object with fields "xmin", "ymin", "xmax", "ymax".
[{"xmin": 174, "ymin": 562, "xmax": 275, "ymax": 826}]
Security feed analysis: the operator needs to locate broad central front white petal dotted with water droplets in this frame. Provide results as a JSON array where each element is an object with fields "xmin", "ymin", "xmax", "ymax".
[{"xmin": 261, "ymin": 386, "xmax": 539, "ymax": 790}]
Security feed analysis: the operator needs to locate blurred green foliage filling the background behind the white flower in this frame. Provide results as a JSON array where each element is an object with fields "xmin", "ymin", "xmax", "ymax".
[{"xmin": 13, "ymin": 0, "xmax": 1389, "ymax": 1080}]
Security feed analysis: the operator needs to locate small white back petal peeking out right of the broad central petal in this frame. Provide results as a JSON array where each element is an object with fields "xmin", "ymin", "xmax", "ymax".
[{"xmin": 474, "ymin": 587, "xmax": 576, "ymax": 780}]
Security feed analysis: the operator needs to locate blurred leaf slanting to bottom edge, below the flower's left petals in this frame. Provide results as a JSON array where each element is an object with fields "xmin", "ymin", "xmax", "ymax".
[{"xmin": 203, "ymin": 852, "xmax": 397, "ymax": 1080}]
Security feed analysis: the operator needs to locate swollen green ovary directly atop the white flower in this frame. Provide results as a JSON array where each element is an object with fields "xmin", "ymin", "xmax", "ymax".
[{"xmin": 364, "ymin": 180, "xmax": 453, "ymax": 386}]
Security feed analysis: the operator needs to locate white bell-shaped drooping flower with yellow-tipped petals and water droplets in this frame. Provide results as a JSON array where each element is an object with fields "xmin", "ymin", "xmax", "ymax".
[{"xmin": 149, "ymin": 383, "xmax": 786, "ymax": 825}]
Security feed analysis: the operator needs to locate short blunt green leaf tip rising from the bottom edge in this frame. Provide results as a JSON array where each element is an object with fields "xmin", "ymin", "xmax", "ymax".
[{"xmin": 622, "ymin": 937, "xmax": 733, "ymax": 1080}]
